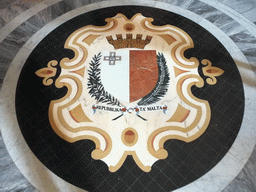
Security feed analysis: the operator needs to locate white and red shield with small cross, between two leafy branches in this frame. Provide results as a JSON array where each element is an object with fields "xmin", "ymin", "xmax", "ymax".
[{"xmin": 101, "ymin": 49, "xmax": 158, "ymax": 103}]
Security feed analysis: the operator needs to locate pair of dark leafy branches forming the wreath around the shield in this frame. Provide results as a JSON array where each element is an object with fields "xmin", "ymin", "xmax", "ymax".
[{"xmin": 87, "ymin": 53, "xmax": 170, "ymax": 107}]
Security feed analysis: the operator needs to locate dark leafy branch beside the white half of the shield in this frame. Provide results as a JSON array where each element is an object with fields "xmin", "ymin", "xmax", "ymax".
[{"xmin": 87, "ymin": 53, "xmax": 121, "ymax": 107}]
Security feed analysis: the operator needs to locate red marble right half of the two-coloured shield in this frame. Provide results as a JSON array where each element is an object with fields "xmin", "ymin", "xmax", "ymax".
[{"xmin": 130, "ymin": 50, "xmax": 158, "ymax": 102}]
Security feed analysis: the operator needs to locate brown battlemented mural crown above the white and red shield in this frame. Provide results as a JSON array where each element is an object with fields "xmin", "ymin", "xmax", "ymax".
[{"xmin": 107, "ymin": 34, "xmax": 152, "ymax": 49}]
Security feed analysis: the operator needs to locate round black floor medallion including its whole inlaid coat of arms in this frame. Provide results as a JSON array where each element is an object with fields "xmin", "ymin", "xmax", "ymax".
[{"xmin": 16, "ymin": 6, "xmax": 244, "ymax": 191}]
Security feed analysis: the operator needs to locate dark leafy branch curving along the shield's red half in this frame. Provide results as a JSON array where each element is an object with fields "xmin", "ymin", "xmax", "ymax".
[{"xmin": 138, "ymin": 53, "xmax": 170, "ymax": 105}]
